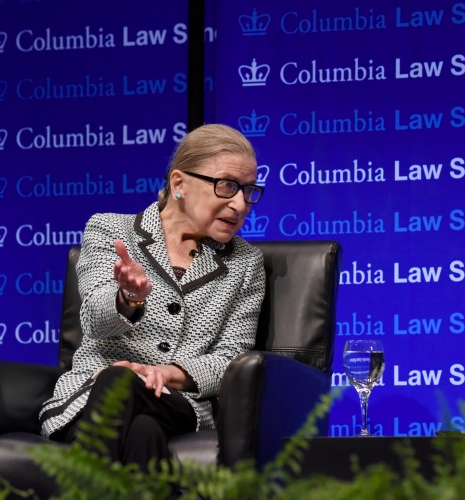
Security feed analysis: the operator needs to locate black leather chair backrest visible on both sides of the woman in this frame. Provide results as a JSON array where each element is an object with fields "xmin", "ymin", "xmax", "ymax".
[{"xmin": 59, "ymin": 241, "xmax": 342, "ymax": 371}]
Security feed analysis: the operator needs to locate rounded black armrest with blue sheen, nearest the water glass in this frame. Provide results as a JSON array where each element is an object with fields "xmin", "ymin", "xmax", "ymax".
[{"xmin": 218, "ymin": 351, "xmax": 331, "ymax": 468}]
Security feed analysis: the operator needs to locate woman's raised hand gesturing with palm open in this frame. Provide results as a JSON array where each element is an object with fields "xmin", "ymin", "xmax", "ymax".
[{"xmin": 113, "ymin": 240, "xmax": 152, "ymax": 300}]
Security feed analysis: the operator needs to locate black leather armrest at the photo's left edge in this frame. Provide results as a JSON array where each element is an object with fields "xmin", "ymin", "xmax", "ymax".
[{"xmin": 0, "ymin": 361, "xmax": 65, "ymax": 434}]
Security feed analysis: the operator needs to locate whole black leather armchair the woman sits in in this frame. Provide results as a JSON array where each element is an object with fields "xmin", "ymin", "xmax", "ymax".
[{"xmin": 0, "ymin": 241, "xmax": 342, "ymax": 498}]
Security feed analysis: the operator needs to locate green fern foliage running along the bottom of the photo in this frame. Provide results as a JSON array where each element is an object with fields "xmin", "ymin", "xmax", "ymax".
[{"xmin": 18, "ymin": 376, "xmax": 465, "ymax": 500}]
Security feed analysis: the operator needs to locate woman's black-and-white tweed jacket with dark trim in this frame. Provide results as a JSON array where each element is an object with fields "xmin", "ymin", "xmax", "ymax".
[{"xmin": 40, "ymin": 203, "xmax": 265, "ymax": 437}]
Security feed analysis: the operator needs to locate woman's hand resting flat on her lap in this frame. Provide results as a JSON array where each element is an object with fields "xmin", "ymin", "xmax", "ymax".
[{"xmin": 114, "ymin": 361, "xmax": 196, "ymax": 398}]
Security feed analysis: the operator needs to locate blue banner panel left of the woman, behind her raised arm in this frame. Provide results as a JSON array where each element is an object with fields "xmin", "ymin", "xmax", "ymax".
[{"xmin": 0, "ymin": 0, "xmax": 187, "ymax": 365}]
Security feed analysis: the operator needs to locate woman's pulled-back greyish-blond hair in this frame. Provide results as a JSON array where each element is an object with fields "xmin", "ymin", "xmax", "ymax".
[{"xmin": 158, "ymin": 124, "xmax": 255, "ymax": 212}]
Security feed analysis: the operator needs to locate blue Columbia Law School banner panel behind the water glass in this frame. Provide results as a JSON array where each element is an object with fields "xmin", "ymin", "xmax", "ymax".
[{"xmin": 216, "ymin": 0, "xmax": 465, "ymax": 436}]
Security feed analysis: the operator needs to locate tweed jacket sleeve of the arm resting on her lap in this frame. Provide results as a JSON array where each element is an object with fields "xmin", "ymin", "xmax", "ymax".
[{"xmin": 175, "ymin": 248, "xmax": 265, "ymax": 399}]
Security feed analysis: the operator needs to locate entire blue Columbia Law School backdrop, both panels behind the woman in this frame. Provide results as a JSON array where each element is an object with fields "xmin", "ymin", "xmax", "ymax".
[{"xmin": 0, "ymin": 0, "xmax": 465, "ymax": 436}]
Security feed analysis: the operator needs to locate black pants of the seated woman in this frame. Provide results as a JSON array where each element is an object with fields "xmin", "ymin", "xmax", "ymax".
[{"xmin": 50, "ymin": 366, "xmax": 197, "ymax": 471}]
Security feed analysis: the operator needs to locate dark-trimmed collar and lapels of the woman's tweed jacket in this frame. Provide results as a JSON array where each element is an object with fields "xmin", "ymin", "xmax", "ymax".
[{"xmin": 134, "ymin": 203, "xmax": 232, "ymax": 296}]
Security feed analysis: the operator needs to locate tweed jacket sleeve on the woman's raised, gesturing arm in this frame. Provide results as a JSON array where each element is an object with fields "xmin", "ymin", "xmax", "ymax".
[{"xmin": 76, "ymin": 214, "xmax": 144, "ymax": 339}]
